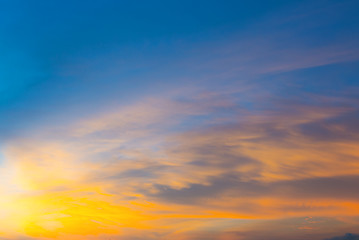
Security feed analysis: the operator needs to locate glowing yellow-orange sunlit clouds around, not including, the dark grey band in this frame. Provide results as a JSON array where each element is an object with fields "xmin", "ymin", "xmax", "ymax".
[{"xmin": 0, "ymin": 98, "xmax": 359, "ymax": 240}]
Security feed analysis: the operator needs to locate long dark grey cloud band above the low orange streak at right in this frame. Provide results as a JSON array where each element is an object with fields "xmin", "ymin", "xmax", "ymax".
[{"xmin": 145, "ymin": 173, "xmax": 359, "ymax": 205}]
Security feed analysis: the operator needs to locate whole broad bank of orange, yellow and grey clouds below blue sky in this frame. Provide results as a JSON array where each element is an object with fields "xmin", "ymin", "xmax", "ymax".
[{"xmin": 2, "ymin": 82, "xmax": 359, "ymax": 239}]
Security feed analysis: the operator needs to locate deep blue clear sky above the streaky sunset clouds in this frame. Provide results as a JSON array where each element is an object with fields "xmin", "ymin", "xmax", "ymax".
[{"xmin": 1, "ymin": 1, "xmax": 359, "ymax": 131}]
